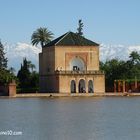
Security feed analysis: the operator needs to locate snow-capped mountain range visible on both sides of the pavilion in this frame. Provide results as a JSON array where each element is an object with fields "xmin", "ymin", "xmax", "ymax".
[{"xmin": 5, "ymin": 43, "xmax": 140, "ymax": 71}]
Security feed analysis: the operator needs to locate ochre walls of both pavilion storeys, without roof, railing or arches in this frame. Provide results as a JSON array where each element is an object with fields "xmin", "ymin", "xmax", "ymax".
[{"xmin": 39, "ymin": 46, "xmax": 105, "ymax": 93}]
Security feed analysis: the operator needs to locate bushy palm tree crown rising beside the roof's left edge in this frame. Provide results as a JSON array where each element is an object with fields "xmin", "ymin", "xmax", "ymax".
[{"xmin": 31, "ymin": 27, "xmax": 53, "ymax": 47}]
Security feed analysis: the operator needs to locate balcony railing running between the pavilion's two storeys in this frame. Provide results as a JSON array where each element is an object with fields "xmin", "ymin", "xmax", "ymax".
[{"xmin": 55, "ymin": 70, "xmax": 104, "ymax": 74}]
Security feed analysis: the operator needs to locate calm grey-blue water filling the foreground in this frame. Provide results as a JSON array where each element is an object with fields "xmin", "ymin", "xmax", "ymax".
[{"xmin": 0, "ymin": 97, "xmax": 140, "ymax": 140}]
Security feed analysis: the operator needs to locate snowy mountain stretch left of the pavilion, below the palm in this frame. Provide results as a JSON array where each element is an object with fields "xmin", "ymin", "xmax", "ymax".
[{"xmin": 5, "ymin": 43, "xmax": 41, "ymax": 71}]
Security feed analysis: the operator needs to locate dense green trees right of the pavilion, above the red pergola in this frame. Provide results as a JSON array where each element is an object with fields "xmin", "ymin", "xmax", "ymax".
[{"xmin": 100, "ymin": 51, "xmax": 140, "ymax": 91}]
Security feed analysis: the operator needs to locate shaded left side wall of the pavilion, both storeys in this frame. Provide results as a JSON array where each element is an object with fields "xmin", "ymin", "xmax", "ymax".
[{"xmin": 39, "ymin": 47, "xmax": 55, "ymax": 92}]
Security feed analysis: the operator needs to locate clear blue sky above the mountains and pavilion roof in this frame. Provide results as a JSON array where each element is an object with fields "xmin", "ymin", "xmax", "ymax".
[{"xmin": 0, "ymin": 0, "xmax": 140, "ymax": 45}]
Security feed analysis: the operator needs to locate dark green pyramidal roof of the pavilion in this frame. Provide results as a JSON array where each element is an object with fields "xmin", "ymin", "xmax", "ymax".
[{"xmin": 46, "ymin": 32, "xmax": 99, "ymax": 47}]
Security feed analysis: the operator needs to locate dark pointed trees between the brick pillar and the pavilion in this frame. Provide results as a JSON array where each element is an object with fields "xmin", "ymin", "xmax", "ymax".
[{"xmin": 17, "ymin": 58, "xmax": 39, "ymax": 92}]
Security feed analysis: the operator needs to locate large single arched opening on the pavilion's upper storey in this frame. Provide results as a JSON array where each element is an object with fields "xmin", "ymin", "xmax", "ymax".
[{"xmin": 70, "ymin": 57, "xmax": 86, "ymax": 71}]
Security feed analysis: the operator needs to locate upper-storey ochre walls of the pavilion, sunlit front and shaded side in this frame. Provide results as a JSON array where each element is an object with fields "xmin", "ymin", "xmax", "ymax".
[{"xmin": 39, "ymin": 46, "xmax": 99, "ymax": 75}]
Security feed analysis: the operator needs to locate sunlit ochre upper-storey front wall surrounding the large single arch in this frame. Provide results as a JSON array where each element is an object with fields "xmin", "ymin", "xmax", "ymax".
[{"xmin": 55, "ymin": 46, "xmax": 99, "ymax": 70}]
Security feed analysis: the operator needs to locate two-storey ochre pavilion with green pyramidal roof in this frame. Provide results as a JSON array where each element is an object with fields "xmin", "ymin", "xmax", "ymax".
[{"xmin": 39, "ymin": 32, "xmax": 105, "ymax": 93}]
